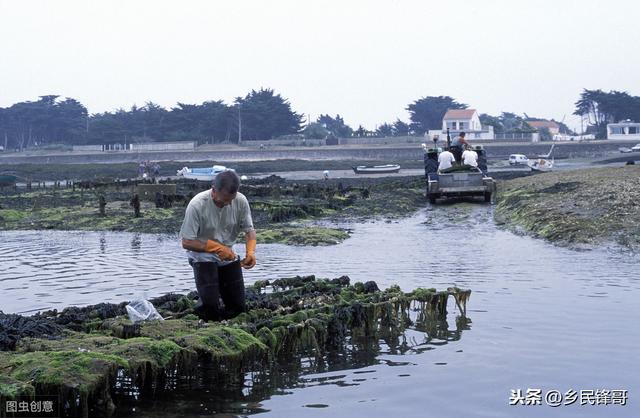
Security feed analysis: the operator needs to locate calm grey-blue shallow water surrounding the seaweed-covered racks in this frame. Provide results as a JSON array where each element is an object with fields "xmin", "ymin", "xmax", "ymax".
[{"xmin": 0, "ymin": 207, "xmax": 640, "ymax": 417}]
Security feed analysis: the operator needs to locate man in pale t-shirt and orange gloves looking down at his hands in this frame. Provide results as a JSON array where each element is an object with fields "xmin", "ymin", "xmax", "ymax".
[{"xmin": 180, "ymin": 171, "xmax": 256, "ymax": 321}]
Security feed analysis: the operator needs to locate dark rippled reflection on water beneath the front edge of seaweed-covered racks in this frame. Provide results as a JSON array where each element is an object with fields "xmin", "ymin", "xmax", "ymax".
[{"xmin": 114, "ymin": 309, "xmax": 470, "ymax": 418}]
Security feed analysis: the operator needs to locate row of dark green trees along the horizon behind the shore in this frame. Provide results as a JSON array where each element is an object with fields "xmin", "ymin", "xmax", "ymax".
[{"xmin": 0, "ymin": 89, "xmax": 640, "ymax": 150}]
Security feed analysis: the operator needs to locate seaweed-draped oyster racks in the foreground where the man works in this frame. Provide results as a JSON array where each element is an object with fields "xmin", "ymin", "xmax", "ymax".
[{"xmin": 0, "ymin": 276, "xmax": 471, "ymax": 416}]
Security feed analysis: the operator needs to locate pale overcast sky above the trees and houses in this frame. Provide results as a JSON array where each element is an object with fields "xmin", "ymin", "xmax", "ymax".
[{"xmin": 0, "ymin": 0, "xmax": 640, "ymax": 129}]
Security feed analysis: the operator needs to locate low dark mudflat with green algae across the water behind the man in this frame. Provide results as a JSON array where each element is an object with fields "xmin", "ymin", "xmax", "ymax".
[{"xmin": 0, "ymin": 173, "xmax": 424, "ymax": 245}]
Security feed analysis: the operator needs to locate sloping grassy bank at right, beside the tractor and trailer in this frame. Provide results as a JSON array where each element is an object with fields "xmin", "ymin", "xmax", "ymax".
[{"xmin": 495, "ymin": 166, "xmax": 640, "ymax": 249}]
